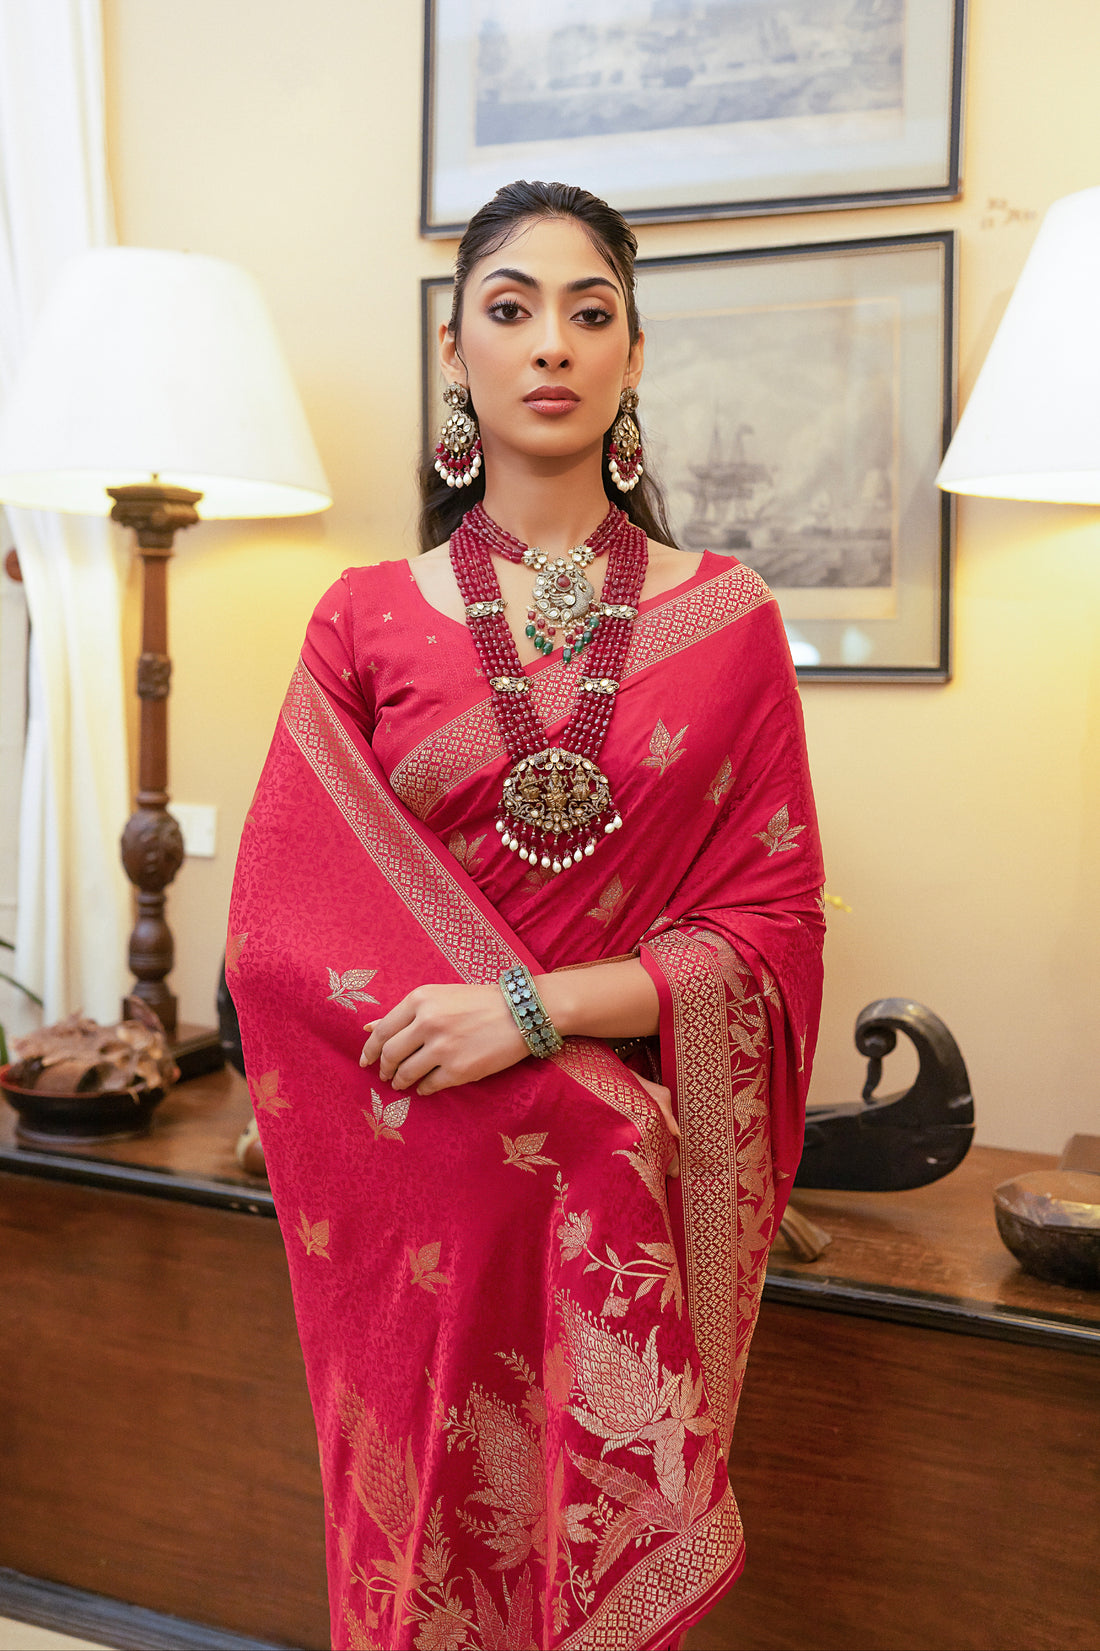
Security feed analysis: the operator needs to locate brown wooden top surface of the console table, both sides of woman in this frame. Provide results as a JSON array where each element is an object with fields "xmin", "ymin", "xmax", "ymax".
[{"xmin": 0, "ymin": 1067, "xmax": 1100, "ymax": 1352}]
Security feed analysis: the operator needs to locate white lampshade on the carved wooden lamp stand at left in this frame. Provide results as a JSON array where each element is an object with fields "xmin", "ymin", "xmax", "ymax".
[{"xmin": 0, "ymin": 246, "xmax": 332, "ymax": 518}]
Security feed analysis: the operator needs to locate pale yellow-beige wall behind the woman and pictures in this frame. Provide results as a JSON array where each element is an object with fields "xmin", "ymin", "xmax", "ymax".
[{"xmin": 104, "ymin": 0, "xmax": 1100, "ymax": 1151}]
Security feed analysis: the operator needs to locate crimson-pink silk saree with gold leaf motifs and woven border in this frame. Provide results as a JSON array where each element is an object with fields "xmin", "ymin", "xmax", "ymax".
[{"xmin": 226, "ymin": 555, "xmax": 823, "ymax": 1651}]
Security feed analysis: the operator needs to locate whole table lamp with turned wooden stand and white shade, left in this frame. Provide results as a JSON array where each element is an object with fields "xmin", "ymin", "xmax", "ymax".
[{"xmin": 0, "ymin": 248, "xmax": 332, "ymax": 1075}]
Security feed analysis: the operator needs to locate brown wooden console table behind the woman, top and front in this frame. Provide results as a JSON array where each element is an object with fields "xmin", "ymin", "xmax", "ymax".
[{"xmin": 0, "ymin": 1071, "xmax": 1100, "ymax": 1651}]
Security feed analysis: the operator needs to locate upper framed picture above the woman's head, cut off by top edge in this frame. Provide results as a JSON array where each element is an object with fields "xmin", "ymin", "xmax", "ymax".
[{"xmin": 421, "ymin": 0, "xmax": 966, "ymax": 236}]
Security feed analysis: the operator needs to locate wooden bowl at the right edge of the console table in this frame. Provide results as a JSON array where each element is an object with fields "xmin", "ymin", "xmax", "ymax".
[{"xmin": 993, "ymin": 1169, "xmax": 1100, "ymax": 1289}]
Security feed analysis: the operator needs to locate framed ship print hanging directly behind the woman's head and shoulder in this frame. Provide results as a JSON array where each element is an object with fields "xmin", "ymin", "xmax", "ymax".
[{"xmin": 423, "ymin": 231, "xmax": 955, "ymax": 682}]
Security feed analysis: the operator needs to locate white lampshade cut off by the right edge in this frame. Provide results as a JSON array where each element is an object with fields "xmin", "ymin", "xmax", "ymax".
[{"xmin": 936, "ymin": 188, "xmax": 1100, "ymax": 505}]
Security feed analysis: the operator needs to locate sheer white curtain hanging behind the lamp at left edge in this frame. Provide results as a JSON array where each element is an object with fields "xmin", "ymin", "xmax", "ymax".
[{"xmin": 0, "ymin": 0, "xmax": 130, "ymax": 1022}]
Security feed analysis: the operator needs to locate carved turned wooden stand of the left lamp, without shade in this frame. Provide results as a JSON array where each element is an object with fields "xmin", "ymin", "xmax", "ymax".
[{"xmin": 107, "ymin": 480, "xmax": 202, "ymax": 1037}]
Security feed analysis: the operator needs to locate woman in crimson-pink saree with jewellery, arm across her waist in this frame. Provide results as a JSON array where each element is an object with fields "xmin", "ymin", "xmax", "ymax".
[{"xmin": 228, "ymin": 183, "xmax": 823, "ymax": 1651}]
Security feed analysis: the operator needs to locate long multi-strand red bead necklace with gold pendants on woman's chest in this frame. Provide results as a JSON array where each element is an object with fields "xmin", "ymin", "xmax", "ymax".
[{"xmin": 451, "ymin": 504, "xmax": 647, "ymax": 873}]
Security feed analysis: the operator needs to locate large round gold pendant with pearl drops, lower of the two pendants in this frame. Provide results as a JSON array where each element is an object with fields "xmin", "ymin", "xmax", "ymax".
[{"xmin": 497, "ymin": 746, "xmax": 623, "ymax": 872}]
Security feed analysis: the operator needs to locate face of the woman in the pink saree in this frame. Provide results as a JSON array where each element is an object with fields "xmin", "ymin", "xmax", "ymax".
[{"xmin": 439, "ymin": 218, "xmax": 642, "ymax": 462}]
